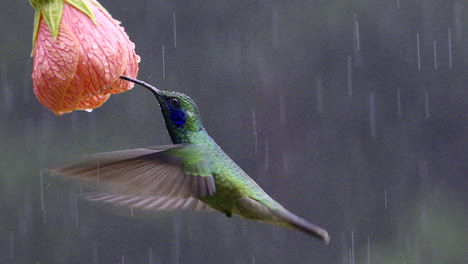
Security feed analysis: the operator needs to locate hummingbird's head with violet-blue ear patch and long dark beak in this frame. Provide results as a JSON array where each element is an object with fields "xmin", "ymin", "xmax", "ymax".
[{"xmin": 120, "ymin": 76, "xmax": 203, "ymax": 137}]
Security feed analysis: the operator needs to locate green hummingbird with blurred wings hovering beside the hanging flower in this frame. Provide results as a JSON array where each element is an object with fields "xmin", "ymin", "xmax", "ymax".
[{"xmin": 52, "ymin": 76, "xmax": 330, "ymax": 244}]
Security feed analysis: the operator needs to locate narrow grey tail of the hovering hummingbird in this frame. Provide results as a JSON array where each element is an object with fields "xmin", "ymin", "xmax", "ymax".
[{"xmin": 270, "ymin": 208, "xmax": 330, "ymax": 244}]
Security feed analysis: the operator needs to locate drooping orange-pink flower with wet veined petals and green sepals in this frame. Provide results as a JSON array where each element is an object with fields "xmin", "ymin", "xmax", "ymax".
[{"xmin": 30, "ymin": 0, "xmax": 140, "ymax": 115}]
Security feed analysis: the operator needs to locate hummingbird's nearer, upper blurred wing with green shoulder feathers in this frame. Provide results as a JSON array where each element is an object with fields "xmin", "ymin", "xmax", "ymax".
[{"xmin": 50, "ymin": 145, "xmax": 215, "ymax": 203}]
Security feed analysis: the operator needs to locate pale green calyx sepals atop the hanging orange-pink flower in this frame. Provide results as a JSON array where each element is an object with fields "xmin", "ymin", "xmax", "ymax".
[{"xmin": 29, "ymin": 0, "xmax": 100, "ymax": 55}]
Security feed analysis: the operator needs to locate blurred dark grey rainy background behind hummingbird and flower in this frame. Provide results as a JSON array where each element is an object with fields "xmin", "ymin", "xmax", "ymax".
[{"xmin": 0, "ymin": 0, "xmax": 468, "ymax": 264}]
